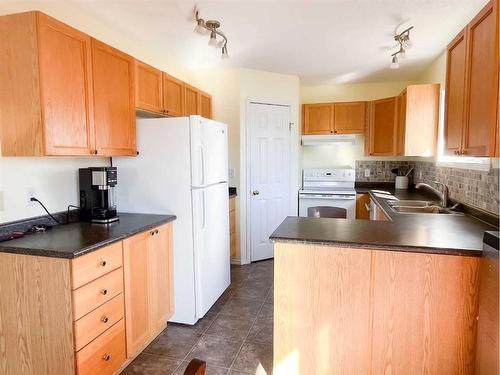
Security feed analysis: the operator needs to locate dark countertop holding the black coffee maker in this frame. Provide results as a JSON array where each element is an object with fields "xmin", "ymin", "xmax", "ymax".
[{"xmin": 0, "ymin": 213, "xmax": 176, "ymax": 259}]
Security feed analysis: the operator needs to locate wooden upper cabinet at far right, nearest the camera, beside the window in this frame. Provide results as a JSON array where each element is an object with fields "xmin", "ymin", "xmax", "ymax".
[{"xmin": 445, "ymin": 1, "xmax": 498, "ymax": 156}]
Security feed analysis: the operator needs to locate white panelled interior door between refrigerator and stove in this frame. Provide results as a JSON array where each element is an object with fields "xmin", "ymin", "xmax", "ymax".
[{"xmin": 247, "ymin": 103, "xmax": 291, "ymax": 261}]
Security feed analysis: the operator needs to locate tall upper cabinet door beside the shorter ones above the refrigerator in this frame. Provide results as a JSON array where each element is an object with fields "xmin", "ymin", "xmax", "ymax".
[{"xmin": 92, "ymin": 39, "xmax": 136, "ymax": 156}]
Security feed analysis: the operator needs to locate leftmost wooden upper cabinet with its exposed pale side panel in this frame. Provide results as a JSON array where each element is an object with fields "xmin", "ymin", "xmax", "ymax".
[{"xmin": 0, "ymin": 12, "xmax": 94, "ymax": 156}]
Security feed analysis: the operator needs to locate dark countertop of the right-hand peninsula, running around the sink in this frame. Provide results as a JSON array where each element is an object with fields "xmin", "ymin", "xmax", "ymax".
[{"xmin": 270, "ymin": 186, "xmax": 498, "ymax": 256}]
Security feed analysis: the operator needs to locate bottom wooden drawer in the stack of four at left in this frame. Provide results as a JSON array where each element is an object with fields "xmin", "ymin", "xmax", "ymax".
[{"xmin": 76, "ymin": 319, "xmax": 125, "ymax": 375}]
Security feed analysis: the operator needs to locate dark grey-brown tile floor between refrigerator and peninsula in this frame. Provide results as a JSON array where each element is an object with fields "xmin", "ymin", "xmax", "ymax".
[{"xmin": 122, "ymin": 260, "xmax": 273, "ymax": 375}]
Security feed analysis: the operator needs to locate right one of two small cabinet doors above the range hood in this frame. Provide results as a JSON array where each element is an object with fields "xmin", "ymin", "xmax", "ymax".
[{"xmin": 333, "ymin": 102, "xmax": 366, "ymax": 134}]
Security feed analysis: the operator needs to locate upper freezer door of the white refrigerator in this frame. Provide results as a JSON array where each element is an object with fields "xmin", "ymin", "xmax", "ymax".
[{"xmin": 190, "ymin": 116, "xmax": 228, "ymax": 187}]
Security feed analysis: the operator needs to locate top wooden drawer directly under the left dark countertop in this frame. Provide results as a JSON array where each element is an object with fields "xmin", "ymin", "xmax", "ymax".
[{"xmin": 71, "ymin": 241, "xmax": 123, "ymax": 290}]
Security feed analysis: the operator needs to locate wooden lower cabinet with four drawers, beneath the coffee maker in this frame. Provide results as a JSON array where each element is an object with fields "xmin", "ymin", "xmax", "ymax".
[{"xmin": 0, "ymin": 223, "xmax": 174, "ymax": 375}]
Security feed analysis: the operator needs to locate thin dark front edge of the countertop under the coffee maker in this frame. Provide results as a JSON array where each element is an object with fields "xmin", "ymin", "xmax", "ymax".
[{"xmin": 0, "ymin": 215, "xmax": 177, "ymax": 259}]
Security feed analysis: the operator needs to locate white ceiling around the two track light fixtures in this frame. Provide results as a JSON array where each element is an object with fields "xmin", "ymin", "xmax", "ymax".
[{"xmin": 68, "ymin": 0, "xmax": 487, "ymax": 85}]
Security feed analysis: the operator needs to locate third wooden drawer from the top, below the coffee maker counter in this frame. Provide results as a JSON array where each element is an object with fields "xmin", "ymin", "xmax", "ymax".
[{"xmin": 75, "ymin": 293, "xmax": 125, "ymax": 351}]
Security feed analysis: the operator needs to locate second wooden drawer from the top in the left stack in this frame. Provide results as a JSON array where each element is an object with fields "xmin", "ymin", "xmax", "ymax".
[{"xmin": 73, "ymin": 267, "xmax": 123, "ymax": 320}]
